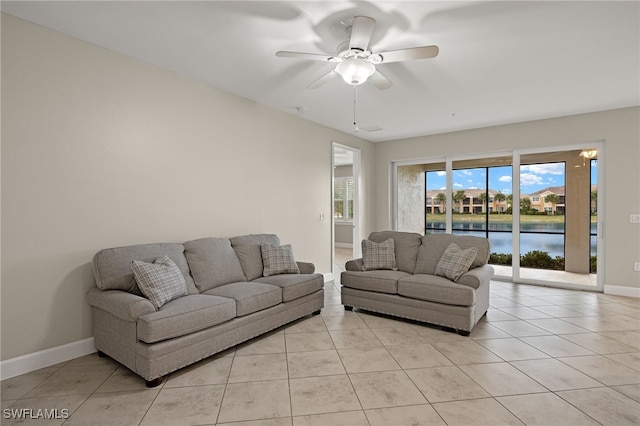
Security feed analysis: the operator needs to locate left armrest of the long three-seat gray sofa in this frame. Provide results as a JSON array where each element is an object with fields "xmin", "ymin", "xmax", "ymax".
[{"xmin": 87, "ymin": 287, "xmax": 156, "ymax": 322}]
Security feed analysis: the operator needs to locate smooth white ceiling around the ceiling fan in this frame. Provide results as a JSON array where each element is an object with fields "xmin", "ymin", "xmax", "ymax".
[{"xmin": 1, "ymin": 1, "xmax": 640, "ymax": 142}]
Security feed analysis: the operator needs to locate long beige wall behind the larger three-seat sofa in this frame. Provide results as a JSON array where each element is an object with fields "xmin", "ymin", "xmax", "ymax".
[{"xmin": 1, "ymin": 14, "xmax": 374, "ymax": 360}]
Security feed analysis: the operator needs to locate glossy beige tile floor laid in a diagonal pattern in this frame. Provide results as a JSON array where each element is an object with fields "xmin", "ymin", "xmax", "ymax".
[{"xmin": 2, "ymin": 276, "xmax": 640, "ymax": 426}]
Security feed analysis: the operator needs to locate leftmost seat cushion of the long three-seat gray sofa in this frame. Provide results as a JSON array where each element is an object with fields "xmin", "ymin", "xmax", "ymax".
[{"xmin": 137, "ymin": 294, "xmax": 236, "ymax": 343}]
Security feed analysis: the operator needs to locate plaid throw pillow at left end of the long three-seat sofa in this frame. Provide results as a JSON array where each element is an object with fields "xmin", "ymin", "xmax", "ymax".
[{"xmin": 131, "ymin": 255, "xmax": 187, "ymax": 309}]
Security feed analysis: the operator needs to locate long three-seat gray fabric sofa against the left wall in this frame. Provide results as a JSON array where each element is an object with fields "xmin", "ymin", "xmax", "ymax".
[{"xmin": 87, "ymin": 234, "xmax": 324, "ymax": 387}]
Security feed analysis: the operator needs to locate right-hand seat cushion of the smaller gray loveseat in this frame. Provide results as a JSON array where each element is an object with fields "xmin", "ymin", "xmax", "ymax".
[{"xmin": 398, "ymin": 274, "xmax": 476, "ymax": 306}]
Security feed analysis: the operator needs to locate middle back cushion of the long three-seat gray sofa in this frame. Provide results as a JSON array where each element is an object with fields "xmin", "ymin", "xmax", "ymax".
[{"xmin": 184, "ymin": 238, "xmax": 247, "ymax": 292}]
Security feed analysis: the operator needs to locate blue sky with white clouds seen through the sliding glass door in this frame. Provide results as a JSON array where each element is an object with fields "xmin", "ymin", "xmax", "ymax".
[{"xmin": 427, "ymin": 161, "xmax": 598, "ymax": 194}]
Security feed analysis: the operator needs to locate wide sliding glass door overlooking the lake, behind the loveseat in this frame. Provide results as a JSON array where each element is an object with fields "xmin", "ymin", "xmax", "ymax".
[{"xmin": 394, "ymin": 144, "xmax": 602, "ymax": 290}]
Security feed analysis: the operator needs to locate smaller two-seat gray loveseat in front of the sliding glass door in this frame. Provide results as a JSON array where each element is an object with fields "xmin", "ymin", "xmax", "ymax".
[{"xmin": 340, "ymin": 231, "xmax": 493, "ymax": 336}]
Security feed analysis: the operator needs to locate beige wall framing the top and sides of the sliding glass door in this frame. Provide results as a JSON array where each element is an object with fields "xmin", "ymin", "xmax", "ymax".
[{"xmin": 375, "ymin": 107, "xmax": 640, "ymax": 293}]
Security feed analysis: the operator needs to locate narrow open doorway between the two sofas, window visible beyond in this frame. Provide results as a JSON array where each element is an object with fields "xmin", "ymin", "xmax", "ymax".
[{"xmin": 331, "ymin": 142, "xmax": 360, "ymax": 277}]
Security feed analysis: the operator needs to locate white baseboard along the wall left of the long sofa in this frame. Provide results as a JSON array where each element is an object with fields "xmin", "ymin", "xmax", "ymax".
[{"xmin": 0, "ymin": 337, "xmax": 96, "ymax": 380}]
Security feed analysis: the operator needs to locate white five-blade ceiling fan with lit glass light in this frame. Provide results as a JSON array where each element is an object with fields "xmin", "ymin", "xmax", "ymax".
[{"xmin": 276, "ymin": 16, "xmax": 439, "ymax": 90}]
